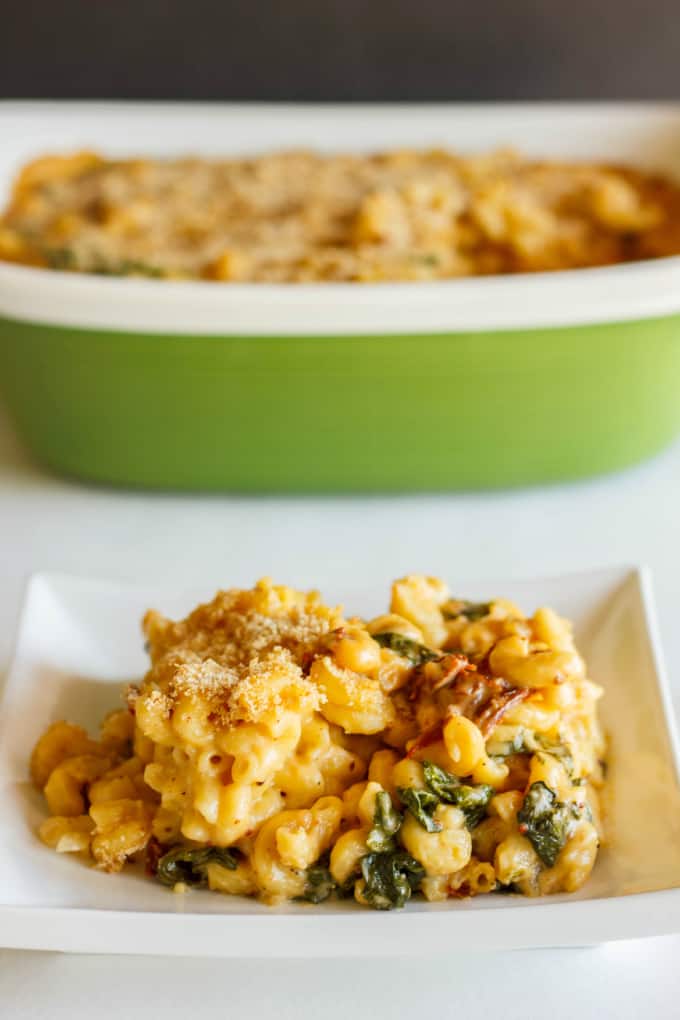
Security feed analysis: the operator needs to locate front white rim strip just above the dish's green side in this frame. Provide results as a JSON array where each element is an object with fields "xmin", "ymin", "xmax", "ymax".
[{"xmin": 0, "ymin": 256, "xmax": 680, "ymax": 337}]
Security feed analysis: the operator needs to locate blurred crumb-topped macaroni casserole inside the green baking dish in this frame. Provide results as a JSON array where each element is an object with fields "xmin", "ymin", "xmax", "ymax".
[{"xmin": 0, "ymin": 149, "xmax": 680, "ymax": 283}]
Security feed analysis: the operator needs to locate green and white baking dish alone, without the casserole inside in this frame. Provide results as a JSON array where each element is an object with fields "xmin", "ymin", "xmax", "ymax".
[{"xmin": 0, "ymin": 103, "xmax": 680, "ymax": 492}]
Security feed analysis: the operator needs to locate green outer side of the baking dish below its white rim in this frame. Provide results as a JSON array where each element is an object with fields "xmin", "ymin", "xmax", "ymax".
[{"xmin": 0, "ymin": 316, "xmax": 680, "ymax": 492}]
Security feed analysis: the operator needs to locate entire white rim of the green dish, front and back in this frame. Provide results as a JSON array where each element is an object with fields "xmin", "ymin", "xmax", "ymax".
[{"xmin": 0, "ymin": 101, "xmax": 680, "ymax": 337}]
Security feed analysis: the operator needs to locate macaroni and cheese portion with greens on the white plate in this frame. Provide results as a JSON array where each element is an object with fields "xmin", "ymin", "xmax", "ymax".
[{"xmin": 31, "ymin": 575, "xmax": 605, "ymax": 910}]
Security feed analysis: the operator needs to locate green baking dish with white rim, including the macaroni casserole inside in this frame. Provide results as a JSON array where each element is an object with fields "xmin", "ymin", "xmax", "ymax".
[{"xmin": 0, "ymin": 103, "xmax": 680, "ymax": 492}]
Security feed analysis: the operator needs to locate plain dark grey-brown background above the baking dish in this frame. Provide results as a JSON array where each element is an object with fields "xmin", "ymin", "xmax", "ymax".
[{"xmin": 0, "ymin": 0, "xmax": 680, "ymax": 100}]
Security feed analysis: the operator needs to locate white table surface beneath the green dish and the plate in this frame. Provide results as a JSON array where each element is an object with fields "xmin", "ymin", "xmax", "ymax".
[{"xmin": 0, "ymin": 401, "xmax": 680, "ymax": 1020}]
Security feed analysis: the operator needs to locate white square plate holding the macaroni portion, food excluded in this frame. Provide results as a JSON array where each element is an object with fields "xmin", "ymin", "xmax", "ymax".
[{"xmin": 0, "ymin": 568, "xmax": 680, "ymax": 957}]
